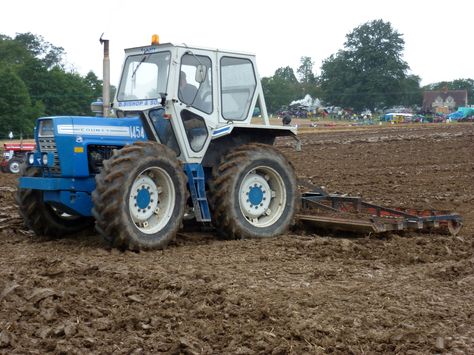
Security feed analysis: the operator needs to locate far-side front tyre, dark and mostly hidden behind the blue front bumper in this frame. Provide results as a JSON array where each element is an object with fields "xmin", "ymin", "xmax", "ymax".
[{"xmin": 16, "ymin": 164, "xmax": 93, "ymax": 238}]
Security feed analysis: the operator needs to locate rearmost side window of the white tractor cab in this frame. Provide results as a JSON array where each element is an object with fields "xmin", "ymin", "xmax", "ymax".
[{"xmin": 221, "ymin": 57, "xmax": 257, "ymax": 120}]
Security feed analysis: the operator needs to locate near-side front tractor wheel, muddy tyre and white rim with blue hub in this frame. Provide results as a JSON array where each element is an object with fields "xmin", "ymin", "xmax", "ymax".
[{"xmin": 92, "ymin": 142, "xmax": 186, "ymax": 251}]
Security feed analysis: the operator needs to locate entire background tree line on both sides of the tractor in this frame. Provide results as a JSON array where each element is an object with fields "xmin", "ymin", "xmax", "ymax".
[{"xmin": 0, "ymin": 20, "xmax": 474, "ymax": 139}]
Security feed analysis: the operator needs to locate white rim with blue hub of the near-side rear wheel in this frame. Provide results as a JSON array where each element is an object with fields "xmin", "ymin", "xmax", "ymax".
[{"xmin": 239, "ymin": 166, "xmax": 287, "ymax": 228}]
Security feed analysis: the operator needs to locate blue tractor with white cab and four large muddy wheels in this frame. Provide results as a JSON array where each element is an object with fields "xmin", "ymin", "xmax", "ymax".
[{"xmin": 17, "ymin": 36, "xmax": 300, "ymax": 250}]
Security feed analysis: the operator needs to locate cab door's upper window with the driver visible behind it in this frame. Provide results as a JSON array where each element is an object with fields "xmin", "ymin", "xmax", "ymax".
[{"xmin": 178, "ymin": 54, "xmax": 213, "ymax": 113}]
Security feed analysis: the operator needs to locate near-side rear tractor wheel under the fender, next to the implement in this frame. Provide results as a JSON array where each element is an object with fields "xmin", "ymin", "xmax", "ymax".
[{"xmin": 210, "ymin": 144, "xmax": 298, "ymax": 239}]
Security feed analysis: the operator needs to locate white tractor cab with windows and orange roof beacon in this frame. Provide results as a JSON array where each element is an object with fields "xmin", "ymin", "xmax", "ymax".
[{"xmin": 113, "ymin": 36, "xmax": 296, "ymax": 166}]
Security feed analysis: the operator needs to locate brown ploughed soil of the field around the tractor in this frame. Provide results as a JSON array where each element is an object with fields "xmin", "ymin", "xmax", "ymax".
[{"xmin": 0, "ymin": 123, "xmax": 474, "ymax": 354}]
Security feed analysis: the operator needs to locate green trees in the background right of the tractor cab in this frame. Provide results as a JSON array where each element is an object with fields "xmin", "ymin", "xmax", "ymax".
[{"xmin": 262, "ymin": 20, "xmax": 474, "ymax": 113}]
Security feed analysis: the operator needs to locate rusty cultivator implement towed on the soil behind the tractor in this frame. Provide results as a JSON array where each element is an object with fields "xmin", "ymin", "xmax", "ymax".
[{"xmin": 297, "ymin": 188, "xmax": 463, "ymax": 235}]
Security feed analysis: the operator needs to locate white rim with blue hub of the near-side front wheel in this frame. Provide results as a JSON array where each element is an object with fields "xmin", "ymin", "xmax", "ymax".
[{"xmin": 129, "ymin": 167, "xmax": 176, "ymax": 234}]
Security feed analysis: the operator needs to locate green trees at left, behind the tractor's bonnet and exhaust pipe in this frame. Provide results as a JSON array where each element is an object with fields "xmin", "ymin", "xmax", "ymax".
[{"xmin": 0, "ymin": 33, "xmax": 102, "ymax": 139}]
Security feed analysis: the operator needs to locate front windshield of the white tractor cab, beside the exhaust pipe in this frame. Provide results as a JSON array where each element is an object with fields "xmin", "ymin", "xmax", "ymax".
[{"xmin": 117, "ymin": 52, "xmax": 171, "ymax": 101}]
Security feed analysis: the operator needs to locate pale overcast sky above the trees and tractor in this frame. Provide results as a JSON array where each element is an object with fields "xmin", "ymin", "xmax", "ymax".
[{"xmin": 0, "ymin": 0, "xmax": 474, "ymax": 85}]
